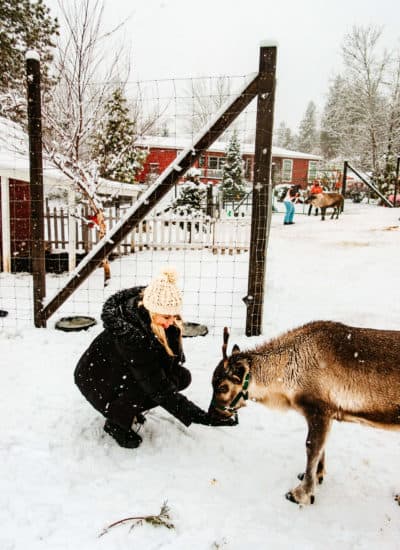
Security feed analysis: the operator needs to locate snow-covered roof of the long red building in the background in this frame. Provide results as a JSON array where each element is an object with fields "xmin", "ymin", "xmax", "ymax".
[{"xmin": 137, "ymin": 136, "xmax": 322, "ymax": 160}]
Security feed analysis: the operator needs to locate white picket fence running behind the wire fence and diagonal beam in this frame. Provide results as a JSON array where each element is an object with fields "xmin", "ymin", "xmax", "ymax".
[{"xmin": 45, "ymin": 205, "xmax": 250, "ymax": 255}]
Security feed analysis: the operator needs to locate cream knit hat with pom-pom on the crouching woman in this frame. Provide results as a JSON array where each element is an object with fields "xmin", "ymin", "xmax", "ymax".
[{"xmin": 143, "ymin": 267, "xmax": 182, "ymax": 315}]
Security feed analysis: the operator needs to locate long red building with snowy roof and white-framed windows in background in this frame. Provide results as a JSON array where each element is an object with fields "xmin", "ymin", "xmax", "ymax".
[{"xmin": 138, "ymin": 136, "xmax": 322, "ymax": 187}]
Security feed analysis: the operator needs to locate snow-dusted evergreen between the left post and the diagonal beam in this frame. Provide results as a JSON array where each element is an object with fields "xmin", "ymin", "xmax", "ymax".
[{"xmin": 93, "ymin": 88, "xmax": 147, "ymax": 183}]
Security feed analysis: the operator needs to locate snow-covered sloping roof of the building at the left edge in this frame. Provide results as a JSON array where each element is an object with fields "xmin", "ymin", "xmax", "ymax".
[{"xmin": 0, "ymin": 117, "xmax": 143, "ymax": 197}]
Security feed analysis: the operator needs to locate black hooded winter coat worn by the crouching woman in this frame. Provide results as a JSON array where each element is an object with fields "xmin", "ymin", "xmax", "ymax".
[{"xmin": 75, "ymin": 287, "xmax": 206, "ymax": 429}]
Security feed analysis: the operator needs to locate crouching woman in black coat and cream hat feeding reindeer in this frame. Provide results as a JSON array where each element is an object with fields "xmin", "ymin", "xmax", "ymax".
[{"xmin": 75, "ymin": 269, "xmax": 237, "ymax": 448}]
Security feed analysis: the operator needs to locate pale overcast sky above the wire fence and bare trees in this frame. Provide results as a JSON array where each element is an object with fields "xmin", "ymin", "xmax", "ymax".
[{"xmin": 47, "ymin": 0, "xmax": 400, "ymax": 130}]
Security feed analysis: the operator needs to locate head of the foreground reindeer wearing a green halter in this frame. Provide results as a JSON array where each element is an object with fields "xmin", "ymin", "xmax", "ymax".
[{"xmin": 208, "ymin": 327, "xmax": 250, "ymax": 416}]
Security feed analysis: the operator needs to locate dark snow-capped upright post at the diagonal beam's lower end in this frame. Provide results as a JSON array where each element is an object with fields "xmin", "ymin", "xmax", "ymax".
[{"xmin": 25, "ymin": 50, "xmax": 46, "ymax": 327}]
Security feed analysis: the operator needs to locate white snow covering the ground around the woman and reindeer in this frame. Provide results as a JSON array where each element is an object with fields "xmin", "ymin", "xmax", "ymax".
[{"xmin": 0, "ymin": 202, "xmax": 400, "ymax": 550}]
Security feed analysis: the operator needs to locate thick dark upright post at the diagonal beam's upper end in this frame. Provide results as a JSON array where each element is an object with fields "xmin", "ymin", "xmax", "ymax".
[{"xmin": 244, "ymin": 45, "xmax": 277, "ymax": 336}]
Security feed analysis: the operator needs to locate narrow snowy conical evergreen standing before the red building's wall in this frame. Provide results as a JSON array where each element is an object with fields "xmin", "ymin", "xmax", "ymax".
[{"xmin": 221, "ymin": 131, "xmax": 246, "ymax": 201}]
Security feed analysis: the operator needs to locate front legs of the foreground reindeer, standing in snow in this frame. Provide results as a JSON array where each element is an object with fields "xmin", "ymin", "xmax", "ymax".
[{"xmin": 286, "ymin": 408, "xmax": 332, "ymax": 504}]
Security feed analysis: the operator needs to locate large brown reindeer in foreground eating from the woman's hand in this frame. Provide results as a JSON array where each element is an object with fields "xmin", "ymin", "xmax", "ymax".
[{"xmin": 209, "ymin": 321, "xmax": 400, "ymax": 504}]
